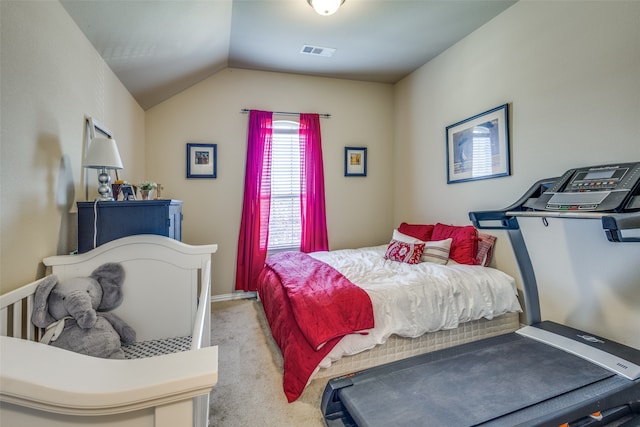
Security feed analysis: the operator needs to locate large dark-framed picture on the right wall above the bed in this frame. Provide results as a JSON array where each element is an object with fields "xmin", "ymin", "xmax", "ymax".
[{"xmin": 446, "ymin": 104, "xmax": 511, "ymax": 184}]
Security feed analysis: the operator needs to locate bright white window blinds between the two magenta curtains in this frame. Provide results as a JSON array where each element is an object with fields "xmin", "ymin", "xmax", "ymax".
[{"xmin": 268, "ymin": 121, "xmax": 301, "ymax": 252}]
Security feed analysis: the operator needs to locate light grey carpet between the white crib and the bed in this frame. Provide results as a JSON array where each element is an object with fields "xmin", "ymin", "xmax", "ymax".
[{"xmin": 209, "ymin": 299, "xmax": 326, "ymax": 427}]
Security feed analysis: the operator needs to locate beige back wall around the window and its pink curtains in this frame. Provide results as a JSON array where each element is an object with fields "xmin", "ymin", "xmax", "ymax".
[{"xmin": 146, "ymin": 69, "xmax": 393, "ymax": 295}]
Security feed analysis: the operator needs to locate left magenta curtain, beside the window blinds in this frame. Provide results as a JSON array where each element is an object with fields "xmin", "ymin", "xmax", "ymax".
[{"xmin": 236, "ymin": 110, "xmax": 273, "ymax": 291}]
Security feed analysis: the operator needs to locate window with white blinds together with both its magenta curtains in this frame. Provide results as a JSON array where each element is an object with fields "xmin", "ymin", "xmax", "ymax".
[{"xmin": 236, "ymin": 110, "xmax": 329, "ymax": 291}]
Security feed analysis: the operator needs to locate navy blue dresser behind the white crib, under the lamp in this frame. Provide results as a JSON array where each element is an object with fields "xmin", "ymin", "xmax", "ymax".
[{"xmin": 78, "ymin": 200, "xmax": 182, "ymax": 253}]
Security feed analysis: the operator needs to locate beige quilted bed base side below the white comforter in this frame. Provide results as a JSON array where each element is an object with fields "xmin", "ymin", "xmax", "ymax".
[{"xmin": 311, "ymin": 313, "xmax": 520, "ymax": 380}]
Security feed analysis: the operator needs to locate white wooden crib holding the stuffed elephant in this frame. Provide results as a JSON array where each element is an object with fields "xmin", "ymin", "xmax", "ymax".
[{"xmin": 0, "ymin": 235, "xmax": 218, "ymax": 427}]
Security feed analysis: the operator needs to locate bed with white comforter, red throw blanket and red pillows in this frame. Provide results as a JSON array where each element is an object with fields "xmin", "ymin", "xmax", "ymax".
[{"xmin": 258, "ymin": 223, "xmax": 521, "ymax": 402}]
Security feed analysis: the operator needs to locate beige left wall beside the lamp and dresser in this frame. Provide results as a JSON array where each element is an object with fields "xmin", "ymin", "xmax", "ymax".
[{"xmin": 0, "ymin": 1, "xmax": 145, "ymax": 293}]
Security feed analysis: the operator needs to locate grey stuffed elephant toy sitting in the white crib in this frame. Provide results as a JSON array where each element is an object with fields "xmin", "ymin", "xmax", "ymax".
[{"xmin": 31, "ymin": 263, "xmax": 136, "ymax": 359}]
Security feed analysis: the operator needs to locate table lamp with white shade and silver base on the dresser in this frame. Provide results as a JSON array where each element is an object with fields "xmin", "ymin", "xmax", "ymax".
[{"xmin": 82, "ymin": 137, "xmax": 122, "ymax": 201}]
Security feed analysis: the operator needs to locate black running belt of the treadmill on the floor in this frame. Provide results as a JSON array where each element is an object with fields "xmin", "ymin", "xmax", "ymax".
[{"xmin": 339, "ymin": 334, "xmax": 614, "ymax": 427}]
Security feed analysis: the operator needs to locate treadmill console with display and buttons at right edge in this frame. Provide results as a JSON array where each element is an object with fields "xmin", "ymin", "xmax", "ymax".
[{"xmin": 529, "ymin": 162, "xmax": 640, "ymax": 212}]
